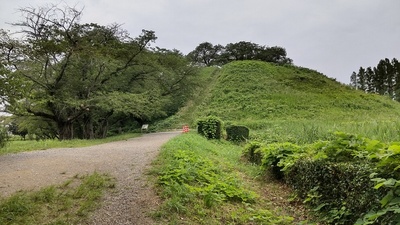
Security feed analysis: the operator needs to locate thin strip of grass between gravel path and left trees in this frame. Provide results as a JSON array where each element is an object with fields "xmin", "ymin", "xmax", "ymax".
[{"xmin": 0, "ymin": 133, "xmax": 140, "ymax": 155}]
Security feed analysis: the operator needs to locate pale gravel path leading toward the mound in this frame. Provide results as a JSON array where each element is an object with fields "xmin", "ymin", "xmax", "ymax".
[{"xmin": 0, "ymin": 132, "xmax": 180, "ymax": 224}]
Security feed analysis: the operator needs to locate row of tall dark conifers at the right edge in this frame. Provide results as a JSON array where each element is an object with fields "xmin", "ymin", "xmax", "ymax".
[{"xmin": 350, "ymin": 58, "xmax": 400, "ymax": 101}]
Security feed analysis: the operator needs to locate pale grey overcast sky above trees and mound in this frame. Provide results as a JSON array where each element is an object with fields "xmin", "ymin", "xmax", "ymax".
[{"xmin": 0, "ymin": 0, "xmax": 400, "ymax": 84}]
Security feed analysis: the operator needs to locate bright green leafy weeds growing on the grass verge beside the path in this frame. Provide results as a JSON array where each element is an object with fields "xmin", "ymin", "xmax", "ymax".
[{"xmin": 158, "ymin": 150, "xmax": 255, "ymax": 204}]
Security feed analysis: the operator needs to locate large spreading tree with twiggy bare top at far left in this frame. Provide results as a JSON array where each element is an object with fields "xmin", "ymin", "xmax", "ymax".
[{"xmin": 1, "ymin": 6, "xmax": 156, "ymax": 139}]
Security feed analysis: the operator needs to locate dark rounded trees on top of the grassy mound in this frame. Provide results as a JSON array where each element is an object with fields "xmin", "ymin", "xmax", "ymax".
[{"xmin": 187, "ymin": 41, "xmax": 293, "ymax": 66}]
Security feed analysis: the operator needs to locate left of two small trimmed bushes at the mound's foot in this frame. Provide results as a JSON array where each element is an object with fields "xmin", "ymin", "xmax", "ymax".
[{"xmin": 197, "ymin": 116, "xmax": 222, "ymax": 139}]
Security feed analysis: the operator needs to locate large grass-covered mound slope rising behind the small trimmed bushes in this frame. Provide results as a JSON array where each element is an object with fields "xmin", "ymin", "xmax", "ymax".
[{"xmin": 166, "ymin": 61, "xmax": 400, "ymax": 142}]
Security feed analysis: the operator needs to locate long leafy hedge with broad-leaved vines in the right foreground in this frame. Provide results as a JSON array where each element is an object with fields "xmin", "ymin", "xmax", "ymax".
[{"xmin": 244, "ymin": 132, "xmax": 400, "ymax": 224}]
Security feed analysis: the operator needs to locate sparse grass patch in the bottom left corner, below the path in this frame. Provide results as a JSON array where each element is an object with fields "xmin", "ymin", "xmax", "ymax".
[{"xmin": 0, "ymin": 173, "xmax": 115, "ymax": 225}]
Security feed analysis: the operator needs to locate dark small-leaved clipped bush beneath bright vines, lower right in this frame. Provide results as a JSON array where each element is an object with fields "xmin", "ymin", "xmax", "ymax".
[{"xmin": 285, "ymin": 159, "xmax": 383, "ymax": 224}]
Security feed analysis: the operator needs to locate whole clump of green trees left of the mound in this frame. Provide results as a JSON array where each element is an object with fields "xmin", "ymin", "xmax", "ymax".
[{"xmin": 0, "ymin": 5, "xmax": 197, "ymax": 140}]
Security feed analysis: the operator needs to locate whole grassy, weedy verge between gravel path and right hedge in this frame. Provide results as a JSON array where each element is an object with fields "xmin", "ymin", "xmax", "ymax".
[{"xmin": 151, "ymin": 132, "xmax": 307, "ymax": 224}]
